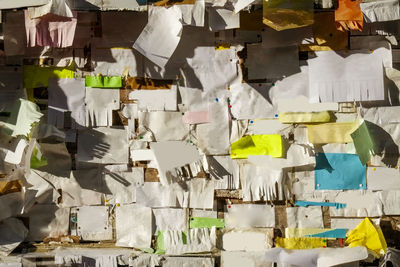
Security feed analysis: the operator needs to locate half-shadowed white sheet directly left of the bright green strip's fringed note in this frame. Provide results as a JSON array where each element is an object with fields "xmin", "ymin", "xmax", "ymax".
[{"xmin": 48, "ymin": 79, "xmax": 86, "ymax": 129}]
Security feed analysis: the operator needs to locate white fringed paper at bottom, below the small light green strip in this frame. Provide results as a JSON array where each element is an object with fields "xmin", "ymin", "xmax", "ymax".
[{"xmin": 157, "ymin": 227, "xmax": 216, "ymax": 255}]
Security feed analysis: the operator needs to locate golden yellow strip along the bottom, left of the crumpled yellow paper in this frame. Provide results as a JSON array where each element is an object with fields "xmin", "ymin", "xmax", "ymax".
[{"xmin": 275, "ymin": 237, "xmax": 326, "ymax": 249}]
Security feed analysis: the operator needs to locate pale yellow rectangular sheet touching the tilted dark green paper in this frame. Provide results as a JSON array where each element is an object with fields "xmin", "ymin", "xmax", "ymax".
[{"xmin": 307, "ymin": 121, "xmax": 358, "ymax": 144}]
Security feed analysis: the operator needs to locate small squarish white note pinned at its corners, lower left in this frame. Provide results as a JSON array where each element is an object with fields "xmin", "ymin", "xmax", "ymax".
[{"xmin": 77, "ymin": 206, "xmax": 113, "ymax": 241}]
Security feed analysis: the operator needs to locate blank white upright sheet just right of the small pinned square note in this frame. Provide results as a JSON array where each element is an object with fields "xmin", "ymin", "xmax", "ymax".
[{"xmin": 115, "ymin": 204, "xmax": 152, "ymax": 248}]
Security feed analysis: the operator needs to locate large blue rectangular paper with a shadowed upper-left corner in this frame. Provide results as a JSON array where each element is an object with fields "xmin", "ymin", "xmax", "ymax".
[{"xmin": 315, "ymin": 153, "xmax": 367, "ymax": 190}]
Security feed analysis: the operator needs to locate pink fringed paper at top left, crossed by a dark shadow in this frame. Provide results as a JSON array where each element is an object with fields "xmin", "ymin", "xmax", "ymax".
[{"xmin": 25, "ymin": 10, "xmax": 78, "ymax": 47}]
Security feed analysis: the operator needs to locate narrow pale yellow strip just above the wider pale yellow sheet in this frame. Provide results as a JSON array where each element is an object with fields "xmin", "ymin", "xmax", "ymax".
[{"xmin": 279, "ymin": 111, "xmax": 331, "ymax": 123}]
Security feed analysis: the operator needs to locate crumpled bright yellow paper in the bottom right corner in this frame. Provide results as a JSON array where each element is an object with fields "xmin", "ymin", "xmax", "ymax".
[{"xmin": 346, "ymin": 218, "xmax": 387, "ymax": 258}]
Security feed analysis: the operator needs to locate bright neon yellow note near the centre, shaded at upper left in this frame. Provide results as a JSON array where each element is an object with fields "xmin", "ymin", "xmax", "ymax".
[{"xmin": 231, "ymin": 134, "xmax": 282, "ymax": 159}]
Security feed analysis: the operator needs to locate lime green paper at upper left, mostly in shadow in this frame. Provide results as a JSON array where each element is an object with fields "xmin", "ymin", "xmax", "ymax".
[{"xmin": 24, "ymin": 65, "xmax": 74, "ymax": 88}]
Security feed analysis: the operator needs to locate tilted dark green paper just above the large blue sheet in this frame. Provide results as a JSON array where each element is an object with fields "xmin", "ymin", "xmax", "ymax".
[{"xmin": 351, "ymin": 121, "xmax": 376, "ymax": 165}]
